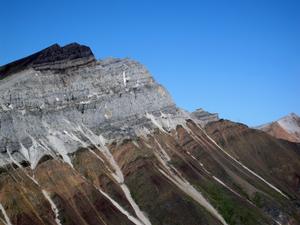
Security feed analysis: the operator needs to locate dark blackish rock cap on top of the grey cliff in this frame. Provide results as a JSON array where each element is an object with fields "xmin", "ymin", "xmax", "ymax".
[{"xmin": 0, "ymin": 43, "xmax": 95, "ymax": 79}]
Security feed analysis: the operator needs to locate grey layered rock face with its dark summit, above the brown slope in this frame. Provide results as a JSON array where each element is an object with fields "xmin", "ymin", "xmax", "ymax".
[{"xmin": 0, "ymin": 44, "xmax": 182, "ymax": 167}]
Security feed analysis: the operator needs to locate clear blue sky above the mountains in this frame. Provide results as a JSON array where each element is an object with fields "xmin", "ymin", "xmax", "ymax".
[{"xmin": 0, "ymin": 0, "xmax": 300, "ymax": 126}]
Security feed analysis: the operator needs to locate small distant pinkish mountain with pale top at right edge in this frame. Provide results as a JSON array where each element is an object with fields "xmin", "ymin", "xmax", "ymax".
[{"xmin": 257, "ymin": 113, "xmax": 300, "ymax": 143}]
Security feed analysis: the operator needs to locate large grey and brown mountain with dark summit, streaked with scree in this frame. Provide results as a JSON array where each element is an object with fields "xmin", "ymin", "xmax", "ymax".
[{"xmin": 0, "ymin": 43, "xmax": 300, "ymax": 225}]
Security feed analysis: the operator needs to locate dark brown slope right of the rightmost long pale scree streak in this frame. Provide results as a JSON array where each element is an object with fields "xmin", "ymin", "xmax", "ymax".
[{"xmin": 205, "ymin": 120, "xmax": 300, "ymax": 223}]
